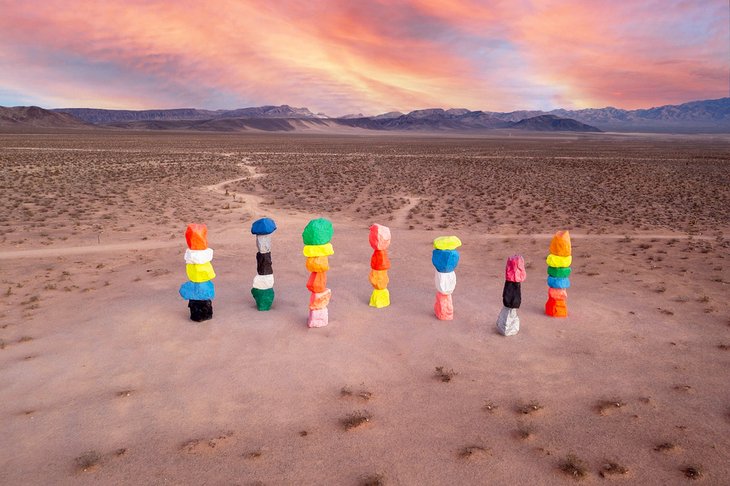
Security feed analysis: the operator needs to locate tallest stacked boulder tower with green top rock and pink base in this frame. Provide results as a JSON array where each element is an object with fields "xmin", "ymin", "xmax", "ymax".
[{"xmin": 302, "ymin": 218, "xmax": 335, "ymax": 327}]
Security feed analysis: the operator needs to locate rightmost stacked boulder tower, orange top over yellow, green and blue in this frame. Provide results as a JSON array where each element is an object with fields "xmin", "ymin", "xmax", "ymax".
[{"xmin": 545, "ymin": 230, "xmax": 573, "ymax": 317}]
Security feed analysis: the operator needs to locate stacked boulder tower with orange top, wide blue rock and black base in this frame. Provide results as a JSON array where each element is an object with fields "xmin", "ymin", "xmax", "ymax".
[{"xmin": 180, "ymin": 224, "xmax": 215, "ymax": 322}]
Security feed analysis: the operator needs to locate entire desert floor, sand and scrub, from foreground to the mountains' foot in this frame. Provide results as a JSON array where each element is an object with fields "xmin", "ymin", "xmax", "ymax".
[{"xmin": 0, "ymin": 131, "xmax": 730, "ymax": 485}]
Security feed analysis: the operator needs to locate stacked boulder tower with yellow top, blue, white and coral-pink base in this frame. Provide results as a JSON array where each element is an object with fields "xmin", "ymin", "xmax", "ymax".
[{"xmin": 431, "ymin": 236, "xmax": 461, "ymax": 321}]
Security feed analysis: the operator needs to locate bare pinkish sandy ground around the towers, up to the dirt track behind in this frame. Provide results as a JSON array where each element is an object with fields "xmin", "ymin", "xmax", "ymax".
[{"xmin": 0, "ymin": 131, "xmax": 730, "ymax": 485}]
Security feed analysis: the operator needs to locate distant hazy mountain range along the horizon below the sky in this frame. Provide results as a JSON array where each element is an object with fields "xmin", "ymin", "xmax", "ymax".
[{"xmin": 0, "ymin": 98, "xmax": 730, "ymax": 133}]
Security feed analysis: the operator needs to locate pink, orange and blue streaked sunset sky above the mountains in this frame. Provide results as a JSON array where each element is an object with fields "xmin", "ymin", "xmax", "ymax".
[{"xmin": 0, "ymin": 0, "xmax": 730, "ymax": 116}]
